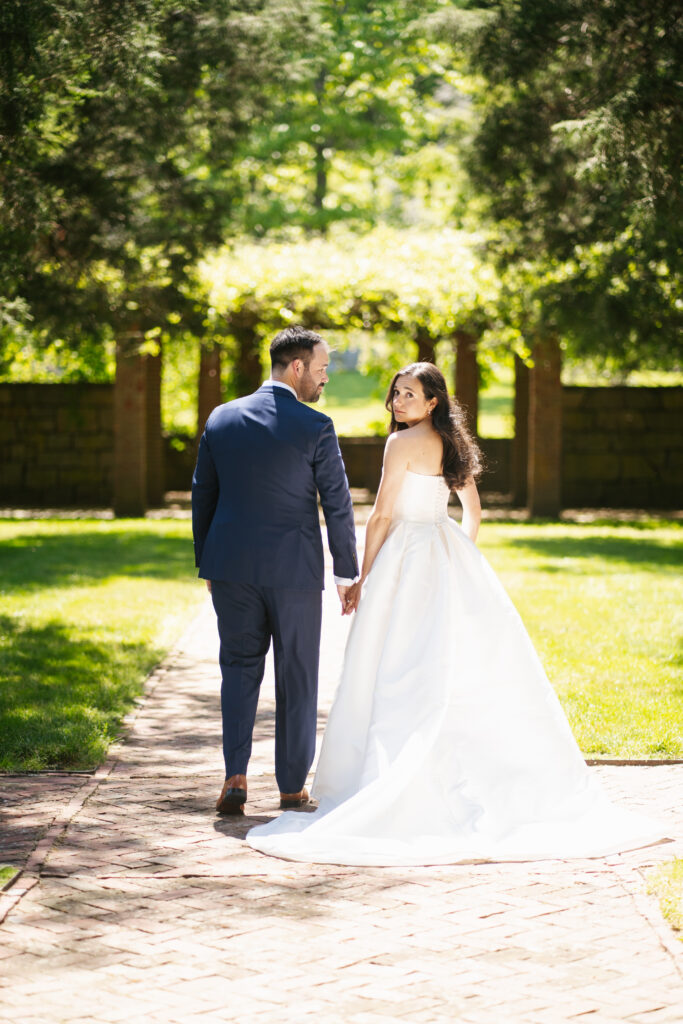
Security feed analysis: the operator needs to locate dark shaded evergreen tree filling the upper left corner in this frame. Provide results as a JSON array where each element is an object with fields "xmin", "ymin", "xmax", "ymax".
[{"xmin": 0, "ymin": 0, "xmax": 315, "ymax": 352}]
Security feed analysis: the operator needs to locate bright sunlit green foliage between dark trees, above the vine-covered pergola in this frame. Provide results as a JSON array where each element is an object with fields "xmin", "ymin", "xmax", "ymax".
[{"xmin": 232, "ymin": 0, "xmax": 469, "ymax": 236}]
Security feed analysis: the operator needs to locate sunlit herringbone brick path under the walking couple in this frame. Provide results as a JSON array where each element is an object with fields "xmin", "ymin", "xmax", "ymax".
[{"xmin": 0, "ymin": 561, "xmax": 683, "ymax": 1024}]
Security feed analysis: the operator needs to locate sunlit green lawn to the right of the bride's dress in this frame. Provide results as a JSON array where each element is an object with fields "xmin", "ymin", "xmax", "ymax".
[{"xmin": 480, "ymin": 521, "xmax": 683, "ymax": 758}]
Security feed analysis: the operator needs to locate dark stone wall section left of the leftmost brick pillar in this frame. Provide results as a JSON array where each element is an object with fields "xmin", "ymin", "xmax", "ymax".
[{"xmin": 0, "ymin": 384, "xmax": 114, "ymax": 508}]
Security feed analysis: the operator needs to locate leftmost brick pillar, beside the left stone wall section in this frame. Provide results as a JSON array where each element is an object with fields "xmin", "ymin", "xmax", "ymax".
[{"xmin": 114, "ymin": 334, "xmax": 147, "ymax": 516}]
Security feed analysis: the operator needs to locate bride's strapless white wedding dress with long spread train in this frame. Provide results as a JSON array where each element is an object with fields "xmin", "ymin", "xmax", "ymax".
[{"xmin": 247, "ymin": 471, "xmax": 666, "ymax": 865}]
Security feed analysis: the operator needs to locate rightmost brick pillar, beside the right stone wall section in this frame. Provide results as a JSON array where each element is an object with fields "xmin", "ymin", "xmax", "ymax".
[{"xmin": 527, "ymin": 337, "xmax": 562, "ymax": 516}]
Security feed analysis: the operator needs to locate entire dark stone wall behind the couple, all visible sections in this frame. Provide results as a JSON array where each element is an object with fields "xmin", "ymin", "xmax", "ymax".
[{"xmin": 0, "ymin": 384, "xmax": 683, "ymax": 508}]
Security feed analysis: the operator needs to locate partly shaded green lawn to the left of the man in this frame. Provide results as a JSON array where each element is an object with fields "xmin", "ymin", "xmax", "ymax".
[{"xmin": 0, "ymin": 520, "xmax": 204, "ymax": 771}]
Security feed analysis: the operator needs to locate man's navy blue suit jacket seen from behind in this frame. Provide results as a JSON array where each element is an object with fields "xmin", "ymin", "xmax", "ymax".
[{"xmin": 193, "ymin": 381, "xmax": 358, "ymax": 590}]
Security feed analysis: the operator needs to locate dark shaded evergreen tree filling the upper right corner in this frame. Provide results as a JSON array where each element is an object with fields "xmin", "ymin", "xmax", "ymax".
[{"xmin": 450, "ymin": 0, "xmax": 683, "ymax": 365}]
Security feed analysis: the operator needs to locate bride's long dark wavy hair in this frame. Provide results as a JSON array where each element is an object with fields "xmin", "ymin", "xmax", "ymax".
[{"xmin": 384, "ymin": 362, "xmax": 483, "ymax": 490}]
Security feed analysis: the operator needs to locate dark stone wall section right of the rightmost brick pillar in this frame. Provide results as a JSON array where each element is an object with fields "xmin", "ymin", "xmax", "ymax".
[{"xmin": 562, "ymin": 387, "xmax": 683, "ymax": 509}]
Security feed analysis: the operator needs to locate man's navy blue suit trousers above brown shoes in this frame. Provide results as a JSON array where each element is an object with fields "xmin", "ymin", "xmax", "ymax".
[{"xmin": 211, "ymin": 580, "xmax": 323, "ymax": 793}]
